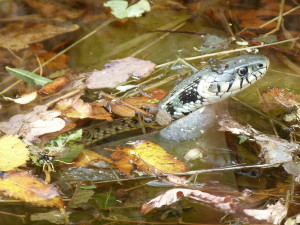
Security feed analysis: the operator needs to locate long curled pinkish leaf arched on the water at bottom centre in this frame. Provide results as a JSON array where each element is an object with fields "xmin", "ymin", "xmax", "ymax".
[{"xmin": 140, "ymin": 188, "xmax": 236, "ymax": 214}]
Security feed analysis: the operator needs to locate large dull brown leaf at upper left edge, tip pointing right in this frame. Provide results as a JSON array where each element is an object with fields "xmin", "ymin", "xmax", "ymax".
[{"xmin": 0, "ymin": 22, "xmax": 79, "ymax": 51}]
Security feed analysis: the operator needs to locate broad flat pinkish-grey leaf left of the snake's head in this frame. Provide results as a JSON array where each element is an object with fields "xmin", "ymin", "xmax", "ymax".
[{"xmin": 85, "ymin": 57, "xmax": 155, "ymax": 89}]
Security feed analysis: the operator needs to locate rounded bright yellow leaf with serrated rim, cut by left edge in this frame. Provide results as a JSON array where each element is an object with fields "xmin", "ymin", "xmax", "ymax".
[{"xmin": 0, "ymin": 135, "xmax": 29, "ymax": 171}]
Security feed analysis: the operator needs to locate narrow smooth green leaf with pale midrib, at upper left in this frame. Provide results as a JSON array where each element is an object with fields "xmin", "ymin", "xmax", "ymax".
[{"xmin": 5, "ymin": 66, "xmax": 52, "ymax": 86}]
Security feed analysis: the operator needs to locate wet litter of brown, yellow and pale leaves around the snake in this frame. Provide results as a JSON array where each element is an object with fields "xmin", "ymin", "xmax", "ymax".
[{"xmin": 0, "ymin": 1, "xmax": 299, "ymax": 224}]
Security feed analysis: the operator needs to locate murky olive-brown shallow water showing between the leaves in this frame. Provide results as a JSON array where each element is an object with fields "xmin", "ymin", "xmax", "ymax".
[{"xmin": 0, "ymin": 1, "xmax": 300, "ymax": 224}]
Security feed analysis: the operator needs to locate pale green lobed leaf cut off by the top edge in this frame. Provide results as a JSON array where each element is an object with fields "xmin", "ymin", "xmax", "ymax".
[{"xmin": 104, "ymin": 0, "xmax": 150, "ymax": 19}]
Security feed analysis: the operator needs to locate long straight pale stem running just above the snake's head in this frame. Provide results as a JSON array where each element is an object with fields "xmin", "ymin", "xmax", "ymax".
[{"xmin": 156, "ymin": 37, "xmax": 300, "ymax": 68}]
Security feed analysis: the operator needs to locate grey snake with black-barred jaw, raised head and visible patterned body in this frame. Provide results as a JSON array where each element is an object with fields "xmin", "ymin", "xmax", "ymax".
[{"xmin": 83, "ymin": 55, "xmax": 270, "ymax": 145}]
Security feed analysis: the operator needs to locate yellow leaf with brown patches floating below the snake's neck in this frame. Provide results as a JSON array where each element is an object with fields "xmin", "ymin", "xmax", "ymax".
[{"xmin": 111, "ymin": 140, "xmax": 187, "ymax": 176}]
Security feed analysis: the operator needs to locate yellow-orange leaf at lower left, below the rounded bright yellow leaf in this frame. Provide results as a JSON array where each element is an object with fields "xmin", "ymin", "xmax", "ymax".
[{"xmin": 0, "ymin": 171, "xmax": 64, "ymax": 209}]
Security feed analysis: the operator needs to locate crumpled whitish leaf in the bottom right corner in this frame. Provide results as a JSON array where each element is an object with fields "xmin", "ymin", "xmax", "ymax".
[{"xmin": 243, "ymin": 201, "xmax": 287, "ymax": 224}]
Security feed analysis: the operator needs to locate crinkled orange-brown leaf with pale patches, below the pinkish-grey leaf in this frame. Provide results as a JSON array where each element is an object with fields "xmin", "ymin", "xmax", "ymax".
[{"xmin": 55, "ymin": 97, "xmax": 112, "ymax": 121}]
